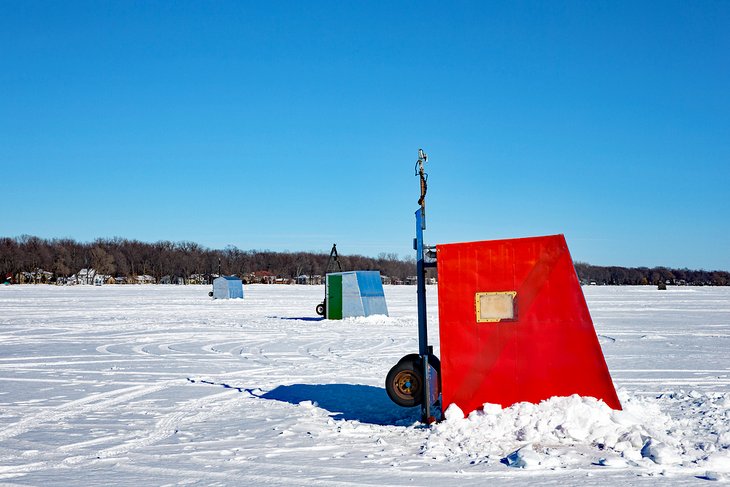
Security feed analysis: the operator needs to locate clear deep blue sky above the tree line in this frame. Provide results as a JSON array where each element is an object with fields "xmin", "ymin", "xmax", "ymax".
[{"xmin": 0, "ymin": 0, "xmax": 730, "ymax": 270}]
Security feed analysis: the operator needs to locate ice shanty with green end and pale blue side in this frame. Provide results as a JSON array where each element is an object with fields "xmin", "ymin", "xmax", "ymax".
[{"xmin": 325, "ymin": 271, "xmax": 388, "ymax": 320}]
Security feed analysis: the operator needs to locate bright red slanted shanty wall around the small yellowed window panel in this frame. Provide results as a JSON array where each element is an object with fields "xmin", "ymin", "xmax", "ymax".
[{"xmin": 437, "ymin": 235, "xmax": 621, "ymax": 414}]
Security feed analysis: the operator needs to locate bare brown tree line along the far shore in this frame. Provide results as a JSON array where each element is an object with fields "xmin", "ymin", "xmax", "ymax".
[{"xmin": 0, "ymin": 235, "xmax": 730, "ymax": 286}]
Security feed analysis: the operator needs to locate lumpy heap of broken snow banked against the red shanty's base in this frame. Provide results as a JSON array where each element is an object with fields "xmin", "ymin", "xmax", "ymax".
[{"xmin": 423, "ymin": 391, "xmax": 730, "ymax": 479}]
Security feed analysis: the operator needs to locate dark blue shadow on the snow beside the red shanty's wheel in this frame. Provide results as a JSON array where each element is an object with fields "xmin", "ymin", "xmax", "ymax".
[{"xmin": 258, "ymin": 384, "xmax": 421, "ymax": 426}]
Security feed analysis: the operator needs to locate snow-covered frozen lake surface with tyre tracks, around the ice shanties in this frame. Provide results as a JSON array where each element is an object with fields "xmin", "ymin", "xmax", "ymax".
[{"xmin": 0, "ymin": 285, "xmax": 730, "ymax": 487}]
